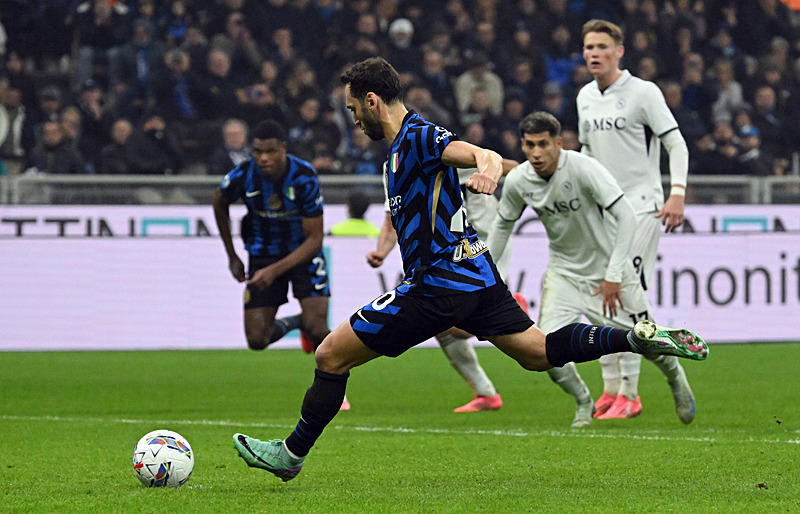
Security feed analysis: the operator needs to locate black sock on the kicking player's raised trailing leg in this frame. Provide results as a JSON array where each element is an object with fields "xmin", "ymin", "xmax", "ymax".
[{"xmin": 545, "ymin": 323, "xmax": 631, "ymax": 367}]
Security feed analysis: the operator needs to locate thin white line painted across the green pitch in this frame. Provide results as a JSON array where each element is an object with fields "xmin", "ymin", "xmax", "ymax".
[{"xmin": 0, "ymin": 414, "xmax": 800, "ymax": 444}]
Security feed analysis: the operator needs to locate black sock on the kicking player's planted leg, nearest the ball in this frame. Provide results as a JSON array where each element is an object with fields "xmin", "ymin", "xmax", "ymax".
[{"xmin": 286, "ymin": 369, "xmax": 350, "ymax": 457}]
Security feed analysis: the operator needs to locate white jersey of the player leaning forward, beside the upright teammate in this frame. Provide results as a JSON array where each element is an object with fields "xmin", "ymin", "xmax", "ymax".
[{"xmin": 497, "ymin": 150, "xmax": 633, "ymax": 282}]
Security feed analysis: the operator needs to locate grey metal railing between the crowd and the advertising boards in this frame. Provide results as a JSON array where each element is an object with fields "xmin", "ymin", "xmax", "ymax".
[{"xmin": 0, "ymin": 174, "xmax": 800, "ymax": 205}]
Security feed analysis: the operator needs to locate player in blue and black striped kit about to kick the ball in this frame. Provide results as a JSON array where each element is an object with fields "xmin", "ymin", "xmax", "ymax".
[{"xmin": 233, "ymin": 57, "xmax": 708, "ymax": 481}]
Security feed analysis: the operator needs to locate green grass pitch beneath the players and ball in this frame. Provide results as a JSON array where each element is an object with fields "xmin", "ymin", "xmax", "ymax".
[{"xmin": 0, "ymin": 344, "xmax": 800, "ymax": 513}]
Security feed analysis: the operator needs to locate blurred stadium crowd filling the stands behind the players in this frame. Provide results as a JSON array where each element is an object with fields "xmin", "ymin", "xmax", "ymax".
[{"xmin": 0, "ymin": 0, "xmax": 800, "ymax": 176}]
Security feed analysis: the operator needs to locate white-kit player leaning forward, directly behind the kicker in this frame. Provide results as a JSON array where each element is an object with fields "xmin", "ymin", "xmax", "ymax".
[{"xmin": 488, "ymin": 112, "xmax": 694, "ymax": 427}]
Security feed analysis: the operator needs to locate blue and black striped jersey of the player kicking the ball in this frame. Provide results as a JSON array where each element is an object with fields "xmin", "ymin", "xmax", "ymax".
[{"xmin": 384, "ymin": 112, "xmax": 501, "ymax": 296}]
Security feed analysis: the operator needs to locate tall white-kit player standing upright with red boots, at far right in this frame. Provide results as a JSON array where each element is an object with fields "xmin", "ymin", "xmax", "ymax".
[{"xmin": 577, "ymin": 20, "xmax": 691, "ymax": 423}]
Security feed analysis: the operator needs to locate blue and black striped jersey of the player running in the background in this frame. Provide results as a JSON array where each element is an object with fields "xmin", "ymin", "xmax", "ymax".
[{"xmin": 220, "ymin": 154, "xmax": 323, "ymax": 257}]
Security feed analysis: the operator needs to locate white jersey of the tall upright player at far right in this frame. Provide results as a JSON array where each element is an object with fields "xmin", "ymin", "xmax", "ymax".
[{"xmin": 577, "ymin": 70, "xmax": 678, "ymax": 212}]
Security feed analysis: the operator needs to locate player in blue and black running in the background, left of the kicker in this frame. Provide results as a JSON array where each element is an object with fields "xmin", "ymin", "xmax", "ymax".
[{"xmin": 213, "ymin": 120, "xmax": 330, "ymax": 353}]
